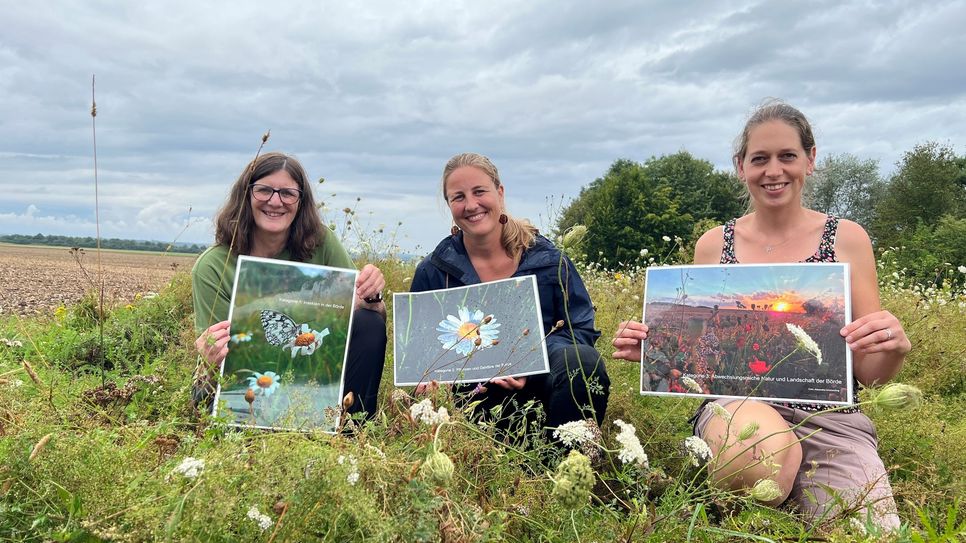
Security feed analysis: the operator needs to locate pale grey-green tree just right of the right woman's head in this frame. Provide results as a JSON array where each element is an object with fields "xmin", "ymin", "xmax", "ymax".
[{"xmin": 804, "ymin": 153, "xmax": 885, "ymax": 230}]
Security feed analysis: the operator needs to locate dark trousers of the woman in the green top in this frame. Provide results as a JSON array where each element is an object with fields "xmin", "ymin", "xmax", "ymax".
[{"xmin": 191, "ymin": 309, "xmax": 386, "ymax": 419}]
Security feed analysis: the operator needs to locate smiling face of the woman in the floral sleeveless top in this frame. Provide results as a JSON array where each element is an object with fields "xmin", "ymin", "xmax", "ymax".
[{"xmin": 738, "ymin": 120, "xmax": 815, "ymax": 209}]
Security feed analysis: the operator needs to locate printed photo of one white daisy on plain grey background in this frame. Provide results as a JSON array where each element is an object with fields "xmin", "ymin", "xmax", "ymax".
[{"xmin": 393, "ymin": 275, "xmax": 550, "ymax": 386}]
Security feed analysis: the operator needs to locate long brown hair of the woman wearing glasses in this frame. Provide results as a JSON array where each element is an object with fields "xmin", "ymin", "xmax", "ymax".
[{"xmin": 215, "ymin": 152, "xmax": 326, "ymax": 262}]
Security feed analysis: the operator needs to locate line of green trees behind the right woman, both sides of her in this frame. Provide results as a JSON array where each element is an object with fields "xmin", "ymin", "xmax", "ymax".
[{"xmin": 556, "ymin": 142, "xmax": 966, "ymax": 282}]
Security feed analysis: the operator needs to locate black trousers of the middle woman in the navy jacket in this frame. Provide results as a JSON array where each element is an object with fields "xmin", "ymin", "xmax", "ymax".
[{"xmin": 457, "ymin": 345, "xmax": 610, "ymax": 438}]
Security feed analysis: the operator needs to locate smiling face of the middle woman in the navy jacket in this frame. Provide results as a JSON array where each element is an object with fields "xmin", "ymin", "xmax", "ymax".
[{"xmin": 444, "ymin": 166, "xmax": 503, "ymax": 239}]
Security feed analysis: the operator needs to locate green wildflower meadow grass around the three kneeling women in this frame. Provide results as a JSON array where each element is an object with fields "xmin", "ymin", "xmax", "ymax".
[{"xmin": 0, "ymin": 258, "xmax": 966, "ymax": 542}]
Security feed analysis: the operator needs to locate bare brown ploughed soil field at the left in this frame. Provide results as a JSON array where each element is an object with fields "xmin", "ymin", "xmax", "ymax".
[{"xmin": 0, "ymin": 243, "xmax": 196, "ymax": 315}]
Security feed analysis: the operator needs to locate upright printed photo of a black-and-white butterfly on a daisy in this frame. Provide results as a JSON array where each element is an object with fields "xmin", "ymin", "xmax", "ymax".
[{"xmin": 214, "ymin": 256, "xmax": 358, "ymax": 432}]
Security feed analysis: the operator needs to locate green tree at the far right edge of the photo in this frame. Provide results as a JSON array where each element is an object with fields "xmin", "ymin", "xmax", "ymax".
[{"xmin": 872, "ymin": 142, "xmax": 966, "ymax": 247}]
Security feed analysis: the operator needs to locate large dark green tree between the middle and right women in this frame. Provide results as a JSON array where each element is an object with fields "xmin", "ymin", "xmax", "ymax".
[{"xmin": 557, "ymin": 151, "xmax": 744, "ymax": 267}]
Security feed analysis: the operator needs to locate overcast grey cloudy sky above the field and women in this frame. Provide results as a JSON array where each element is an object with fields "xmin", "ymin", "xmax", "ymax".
[{"xmin": 0, "ymin": 0, "xmax": 966, "ymax": 253}]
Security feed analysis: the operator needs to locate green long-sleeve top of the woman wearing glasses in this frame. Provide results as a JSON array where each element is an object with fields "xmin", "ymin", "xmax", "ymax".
[{"xmin": 191, "ymin": 236, "xmax": 356, "ymax": 334}]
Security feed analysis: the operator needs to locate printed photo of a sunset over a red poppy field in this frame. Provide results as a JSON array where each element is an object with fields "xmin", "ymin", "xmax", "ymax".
[{"xmin": 641, "ymin": 263, "xmax": 854, "ymax": 406}]
